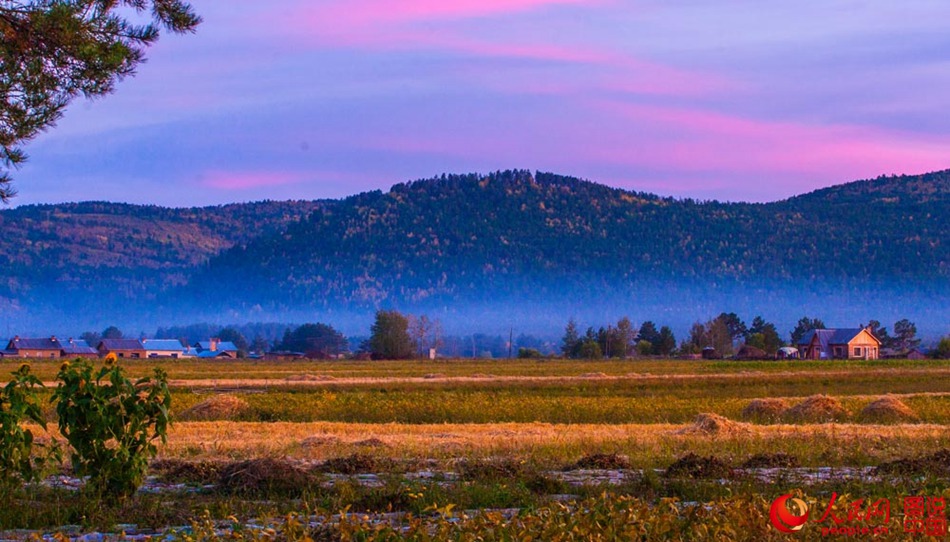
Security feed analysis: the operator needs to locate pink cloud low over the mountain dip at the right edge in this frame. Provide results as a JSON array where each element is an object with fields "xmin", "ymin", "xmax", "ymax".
[{"xmin": 589, "ymin": 103, "xmax": 950, "ymax": 191}]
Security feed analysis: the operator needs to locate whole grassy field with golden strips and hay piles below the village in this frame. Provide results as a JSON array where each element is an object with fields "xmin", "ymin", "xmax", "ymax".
[{"xmin": 0, "ymin": 360, "xmax": 950, "ymax": 540}]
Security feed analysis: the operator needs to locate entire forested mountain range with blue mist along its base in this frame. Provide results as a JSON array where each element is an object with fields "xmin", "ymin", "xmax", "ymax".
[{"xmin": 0, "ymin": 170, "xmax": 950, "ymax": 338}]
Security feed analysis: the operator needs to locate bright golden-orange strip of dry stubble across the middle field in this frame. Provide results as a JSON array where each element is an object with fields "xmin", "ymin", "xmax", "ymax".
[{"xmin": 145, "ymin": 422, "xmax": 950, "ymax": 468}]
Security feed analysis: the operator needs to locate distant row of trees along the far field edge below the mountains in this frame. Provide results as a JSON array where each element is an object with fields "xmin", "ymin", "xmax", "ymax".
[{"xmin": 72, "ymin": 310, "xmax": 936, "ymax": 359}]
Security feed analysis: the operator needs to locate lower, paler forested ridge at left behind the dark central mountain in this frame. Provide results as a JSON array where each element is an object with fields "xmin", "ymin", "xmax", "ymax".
[{"xmin": 0, "ymin": 201, "xmax": 322, "ymax": 299}]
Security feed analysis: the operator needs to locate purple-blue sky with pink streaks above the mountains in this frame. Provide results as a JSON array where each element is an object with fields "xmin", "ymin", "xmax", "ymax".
[{"xmin": 15, "ymin": 0, "xmax": 950, "ymax": 206}]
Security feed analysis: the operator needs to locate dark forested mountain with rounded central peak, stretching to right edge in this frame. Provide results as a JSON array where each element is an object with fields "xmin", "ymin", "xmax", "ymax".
[{"xmin": 196, "ymin": 171, "xmax": 950, "ymax": 306}]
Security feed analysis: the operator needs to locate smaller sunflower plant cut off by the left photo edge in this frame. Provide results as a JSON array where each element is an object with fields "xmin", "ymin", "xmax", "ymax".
[{"xmin": 0, "ymin": 363, "xmax": 54, "ymax": 487}]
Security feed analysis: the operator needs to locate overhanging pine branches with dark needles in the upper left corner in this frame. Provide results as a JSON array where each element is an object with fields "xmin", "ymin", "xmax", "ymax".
[{"xmin": 0, "ymin": 0, "xmax": 201, "ymax": 203}]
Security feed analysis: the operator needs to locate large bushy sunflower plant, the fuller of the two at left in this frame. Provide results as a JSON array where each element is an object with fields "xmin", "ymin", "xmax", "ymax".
[{"xmin": 53, "ymin": 359, "xmax": 171, "ymax": 500}]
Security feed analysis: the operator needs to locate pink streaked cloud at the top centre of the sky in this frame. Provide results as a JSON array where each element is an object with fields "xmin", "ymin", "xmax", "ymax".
[{"xmin": 275, "ymin": 0, "xmax": 740, "ymax": 100}]
